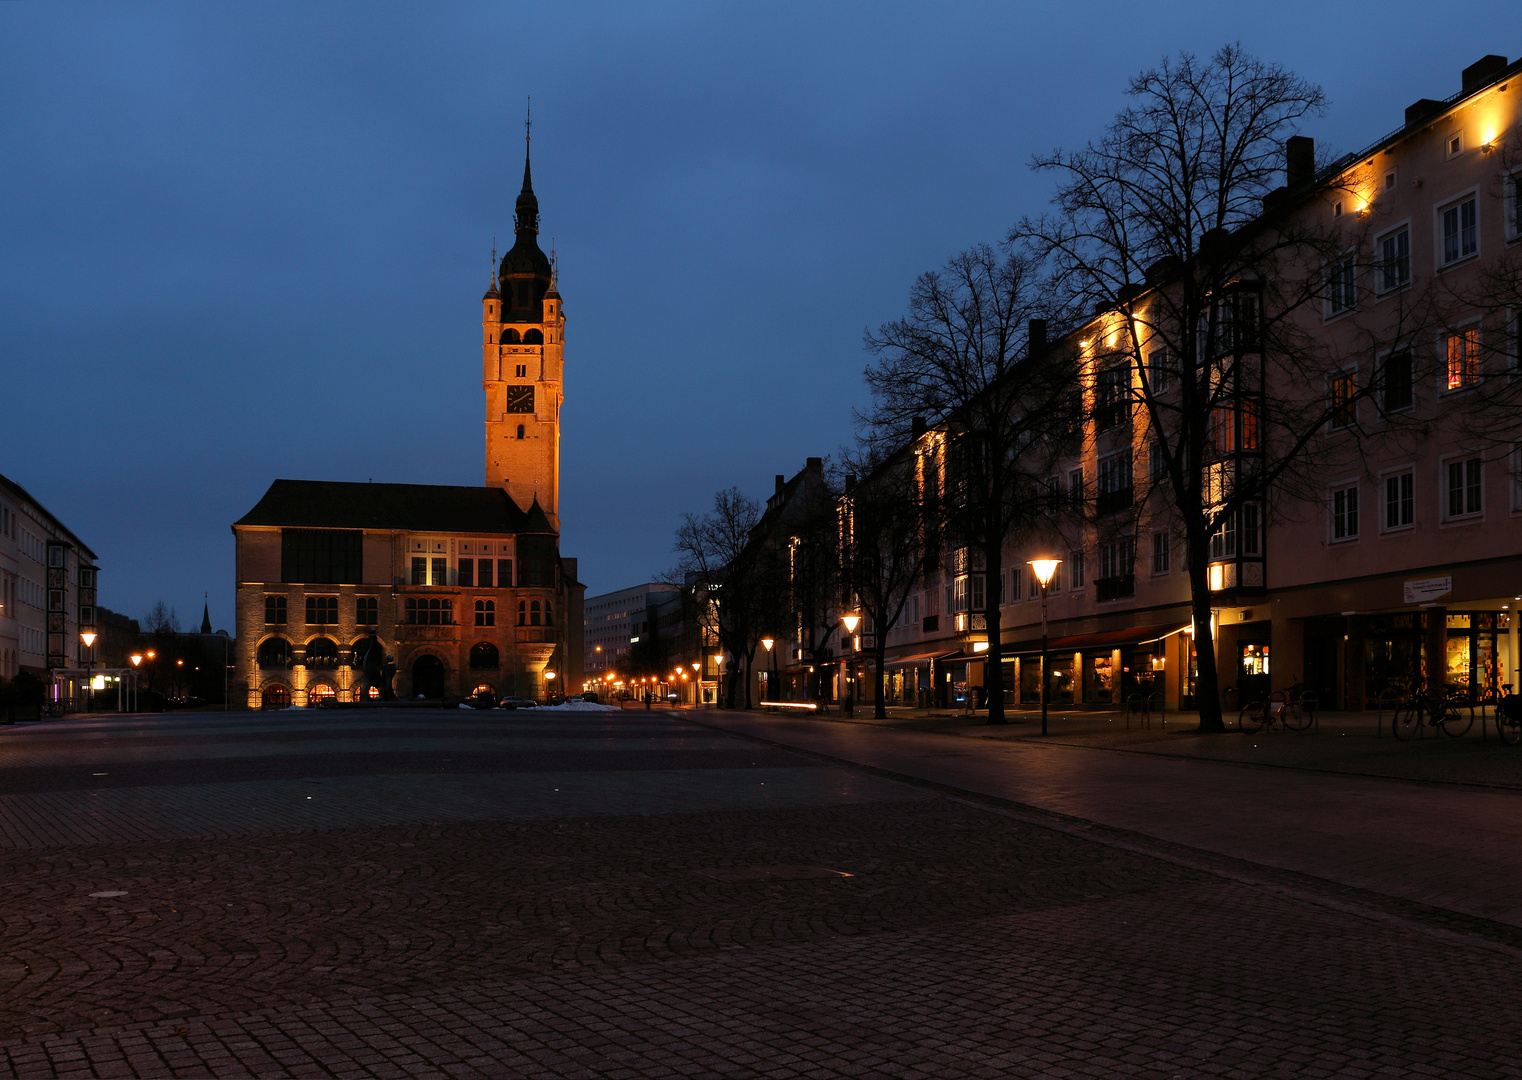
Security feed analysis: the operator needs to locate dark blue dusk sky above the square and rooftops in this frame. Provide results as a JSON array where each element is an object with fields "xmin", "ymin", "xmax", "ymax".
[{"xmin": 0, "ymin": 0, "xmax": 1522, "ymax": 627}]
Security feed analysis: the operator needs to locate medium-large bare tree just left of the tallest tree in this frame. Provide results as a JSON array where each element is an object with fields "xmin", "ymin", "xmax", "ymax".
[{"xmin": 857, "ymin": 245, "xmax": 1076, "ymax": 724}]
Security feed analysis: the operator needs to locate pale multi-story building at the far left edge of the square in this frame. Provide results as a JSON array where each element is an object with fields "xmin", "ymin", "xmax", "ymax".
[{"xmin": 0, "ymin": 476, "xmax": 99, "ymax": 698}]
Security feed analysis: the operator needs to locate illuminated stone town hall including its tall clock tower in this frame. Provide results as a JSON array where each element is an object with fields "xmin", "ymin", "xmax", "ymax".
[{"xmin": 233, "ymin": 146, "xmax": 583, "ymax": 707}]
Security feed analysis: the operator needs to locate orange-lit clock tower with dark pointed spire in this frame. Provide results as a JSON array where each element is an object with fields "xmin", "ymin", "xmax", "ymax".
[{"xmin": 481, "ymin": 141, "xmax": 566, "ymax": 532}]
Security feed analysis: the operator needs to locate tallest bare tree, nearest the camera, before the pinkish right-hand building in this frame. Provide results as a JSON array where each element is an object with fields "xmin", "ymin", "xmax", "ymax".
[{"xmin": 1008, "ymin": 46, "xmax": 1425, "ymax": 732}]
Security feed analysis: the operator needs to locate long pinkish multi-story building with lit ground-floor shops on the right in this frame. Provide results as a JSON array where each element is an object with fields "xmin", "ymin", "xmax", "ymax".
[{"xmin": 785, "ymin": 56, "xmax": 1522, "ymax": 709}]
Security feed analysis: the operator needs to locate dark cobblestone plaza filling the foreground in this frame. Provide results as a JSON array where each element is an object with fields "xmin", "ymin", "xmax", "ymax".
[{"xmin": 0, "ymin": 710, "xmax": 1522, "ymax": 1078}]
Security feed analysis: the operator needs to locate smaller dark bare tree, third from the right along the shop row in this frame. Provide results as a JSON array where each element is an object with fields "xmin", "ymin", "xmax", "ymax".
[{"xmin": 839, "ymin": 444, "xmax": 927, "ymax": 719}]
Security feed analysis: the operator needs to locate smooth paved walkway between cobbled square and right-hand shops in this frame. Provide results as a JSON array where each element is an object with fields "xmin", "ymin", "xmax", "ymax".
[{"xmin": 682, "ymin": 710, "xmax": 1522, "ymax": 926}]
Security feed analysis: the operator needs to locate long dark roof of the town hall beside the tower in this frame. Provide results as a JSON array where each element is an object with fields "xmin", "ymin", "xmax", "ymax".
[{"xmin": 233, "ymin": 481, "xmax": 554, "ymax": 534}]
